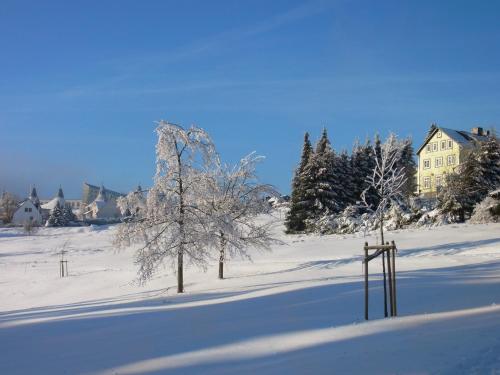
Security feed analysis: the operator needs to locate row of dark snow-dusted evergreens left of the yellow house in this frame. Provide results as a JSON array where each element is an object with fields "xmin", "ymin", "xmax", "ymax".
[{"xmin": 285, "ymin": 129, "xmax": 416, "ymax": 233}]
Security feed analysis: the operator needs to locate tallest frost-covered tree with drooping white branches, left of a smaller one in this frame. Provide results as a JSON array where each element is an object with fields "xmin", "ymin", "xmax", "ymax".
[{"xmin": 116, "ymin": 121, "xmax": 218, "ymax": 293}]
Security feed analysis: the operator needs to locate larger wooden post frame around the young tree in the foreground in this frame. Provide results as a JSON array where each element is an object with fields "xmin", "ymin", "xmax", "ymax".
[{"xmin": 363, "ymin": 241, "xmax": 398, "ymax": 320}]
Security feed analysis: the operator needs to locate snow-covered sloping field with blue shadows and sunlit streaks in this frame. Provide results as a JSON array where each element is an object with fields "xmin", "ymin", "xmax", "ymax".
[{"xmin": 0, "ymin": 224, "xmax": 500, "ymax": 374}]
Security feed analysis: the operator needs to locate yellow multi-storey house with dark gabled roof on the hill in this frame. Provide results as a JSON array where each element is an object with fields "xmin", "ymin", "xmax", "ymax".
[{"xmin": 417, "ymin": 126, "xmax": 489, "ymax": 198}]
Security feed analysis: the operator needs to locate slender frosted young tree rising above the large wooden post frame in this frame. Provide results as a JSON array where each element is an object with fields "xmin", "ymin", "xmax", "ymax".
[{"xmin": 361, "ymin": 134, "xmax": 406, "ymax": 244}]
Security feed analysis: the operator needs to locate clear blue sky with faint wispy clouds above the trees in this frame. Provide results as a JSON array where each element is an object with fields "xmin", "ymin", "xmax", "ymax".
[{"xmin": 0, "ymin": 0, "xmax": 500, "ymax": 197}]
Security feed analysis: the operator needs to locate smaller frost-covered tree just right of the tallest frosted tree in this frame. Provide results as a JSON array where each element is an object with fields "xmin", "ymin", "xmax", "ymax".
[{"xmin": 203, "ymin": 154, "xmax": 277, "ymax": 279}]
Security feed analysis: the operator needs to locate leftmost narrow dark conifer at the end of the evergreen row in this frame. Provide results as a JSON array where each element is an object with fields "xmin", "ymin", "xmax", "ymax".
[{"xmin": 285, "ymin": 133, "xmax": 313, "ymax": 233}]
